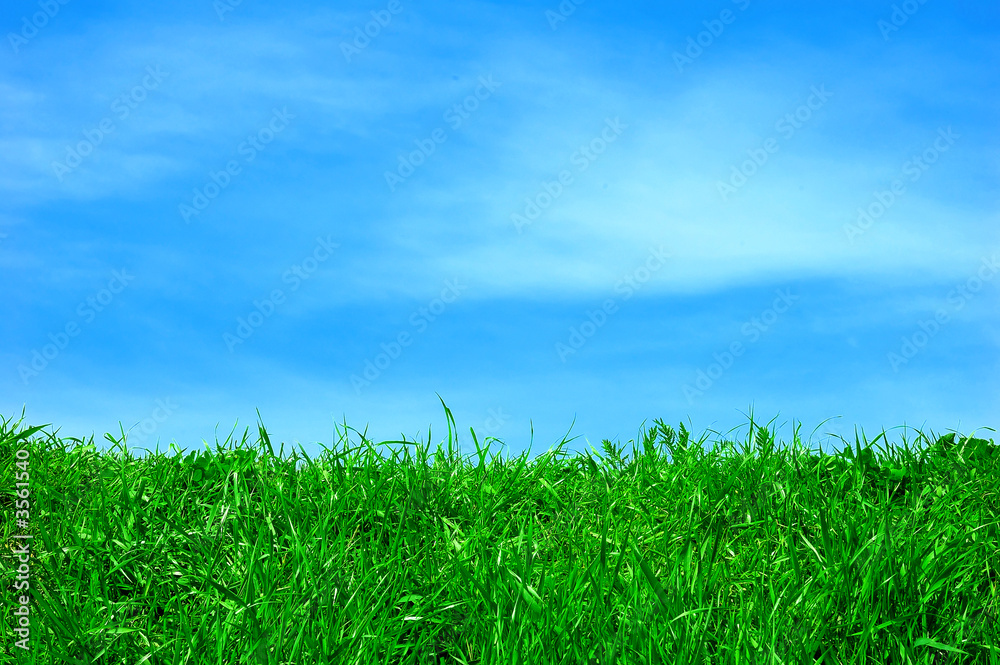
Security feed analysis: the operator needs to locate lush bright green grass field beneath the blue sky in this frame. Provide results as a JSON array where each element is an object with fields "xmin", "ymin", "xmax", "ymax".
[{"xmin": 0, "ymin": 400, "xmax": 1000, "ymax": 665}]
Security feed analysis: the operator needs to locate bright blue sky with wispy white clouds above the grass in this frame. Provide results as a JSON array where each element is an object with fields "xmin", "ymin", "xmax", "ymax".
[{"xmin": 0, "ymin": 0, "xmax": 1000, "ymax": 464}]
